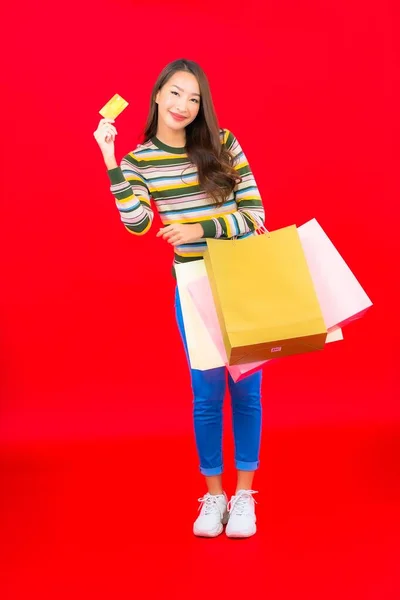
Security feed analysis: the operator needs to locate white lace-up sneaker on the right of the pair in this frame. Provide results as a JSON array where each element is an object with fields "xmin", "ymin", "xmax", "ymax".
[{"xmin": 225, "ymin": 490, "xmax": 257, "ymax": 537}]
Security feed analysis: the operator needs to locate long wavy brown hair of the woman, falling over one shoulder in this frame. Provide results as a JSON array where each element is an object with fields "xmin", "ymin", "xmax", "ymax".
[{"xmin": 144, "ymin": 58, "xmax": 241, "ymax": 206}]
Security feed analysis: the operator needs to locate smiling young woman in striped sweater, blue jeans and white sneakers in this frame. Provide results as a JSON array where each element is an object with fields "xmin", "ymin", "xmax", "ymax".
[{"xmin": 94, "ymin": 59, "xmax": 264, "ymax": 537}]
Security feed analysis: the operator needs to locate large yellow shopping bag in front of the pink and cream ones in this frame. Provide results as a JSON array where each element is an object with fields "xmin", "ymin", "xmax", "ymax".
[{"xmin": 204, "ymin": 225, "xmax": 327, "ymax": 365}]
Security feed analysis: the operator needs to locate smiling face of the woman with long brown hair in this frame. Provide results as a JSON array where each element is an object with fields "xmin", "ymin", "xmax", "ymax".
[{"xmin": 156, "ymin": 71, "xmax": 200, "ymax": 131}]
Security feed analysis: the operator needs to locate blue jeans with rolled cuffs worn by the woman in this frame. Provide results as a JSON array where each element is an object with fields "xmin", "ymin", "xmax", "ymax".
[{"xmin": 175, "ymin": 287, "xmax": 261, "ymax": 476}]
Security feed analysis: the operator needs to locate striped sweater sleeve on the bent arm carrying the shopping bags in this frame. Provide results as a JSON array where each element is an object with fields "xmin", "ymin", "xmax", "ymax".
[{"xmin": 201, "ymin": 130, "xmax": 265, "ymax": 239}]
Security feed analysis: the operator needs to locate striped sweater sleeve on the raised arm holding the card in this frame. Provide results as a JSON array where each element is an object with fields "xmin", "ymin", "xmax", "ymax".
[{"xmin": 108, "ymin": 153, "xmax": 154, "ymax": 235}]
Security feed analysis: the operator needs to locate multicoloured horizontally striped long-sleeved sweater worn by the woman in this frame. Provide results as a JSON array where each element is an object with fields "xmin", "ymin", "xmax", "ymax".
[{"xmin": 108, "ymin": 130, "xmax": 264, "ymax": 263}]
